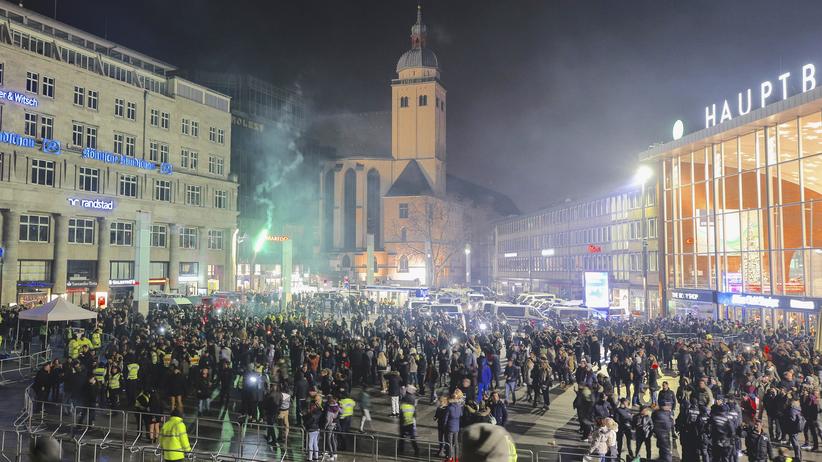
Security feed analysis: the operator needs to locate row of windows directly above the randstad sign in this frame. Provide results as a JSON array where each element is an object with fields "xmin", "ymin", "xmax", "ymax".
[{"xmin": 30, "ymin": 159, "xmax": 228, "ymax": 209}]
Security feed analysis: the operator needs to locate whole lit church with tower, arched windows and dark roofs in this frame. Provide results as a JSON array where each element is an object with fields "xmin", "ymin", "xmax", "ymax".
[{"xmin": 312, "ymin": 8, "xmax": 518, "ymax": 287}]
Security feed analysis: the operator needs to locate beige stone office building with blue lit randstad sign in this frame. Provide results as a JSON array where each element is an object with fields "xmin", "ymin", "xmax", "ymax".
[{"xmin": 0, "ymin": 2, "xmax": 237, "ymax": 305}]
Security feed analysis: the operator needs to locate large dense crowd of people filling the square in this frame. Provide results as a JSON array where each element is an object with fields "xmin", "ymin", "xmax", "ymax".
[{"xmin": 16, "ymin": 297, "xmax": 822, "ymax": 462}]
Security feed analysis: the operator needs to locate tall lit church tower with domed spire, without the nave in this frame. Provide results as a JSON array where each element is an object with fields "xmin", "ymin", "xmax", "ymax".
[{"xmin": 391, "ymin": 6, "xmax": 446, "ymax": 195}]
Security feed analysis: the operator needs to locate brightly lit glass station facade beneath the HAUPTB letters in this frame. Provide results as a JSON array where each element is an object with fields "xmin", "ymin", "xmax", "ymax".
[{"xmin": 660, "ymin": 112, "xmax": 822, "ymax": 326}]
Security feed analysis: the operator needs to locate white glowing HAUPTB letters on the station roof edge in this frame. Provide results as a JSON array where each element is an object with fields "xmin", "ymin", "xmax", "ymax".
[{"xmin": 705, "ymin": 64, "xmax": 816, "ymax": 128}]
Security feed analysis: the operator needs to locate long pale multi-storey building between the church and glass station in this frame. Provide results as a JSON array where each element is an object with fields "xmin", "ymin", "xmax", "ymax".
[{"xmin": 494, "ymin": 187, "xmax": 660, "ymax": 316}]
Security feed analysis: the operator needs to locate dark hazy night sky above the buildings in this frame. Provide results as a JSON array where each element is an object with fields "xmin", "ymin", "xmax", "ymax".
[{"xmin": 19, "ymin": 0, "xmax": 822, "ymax": 210}]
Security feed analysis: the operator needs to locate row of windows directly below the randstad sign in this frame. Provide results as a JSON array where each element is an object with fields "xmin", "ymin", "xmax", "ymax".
[{"xmin": 20, "ymin": 215, "xmax": 225, "ymax": 250}]
